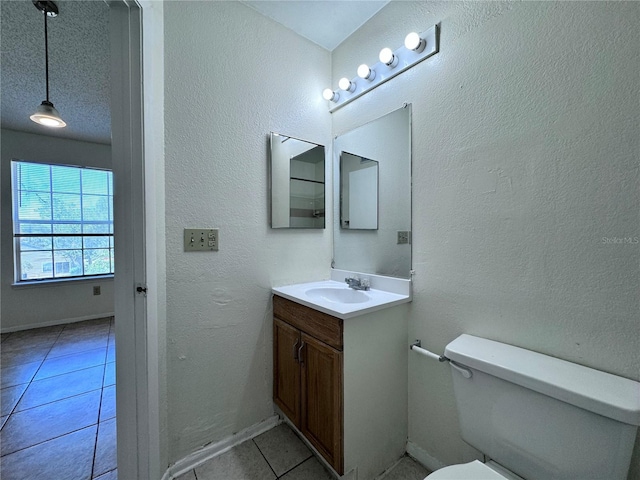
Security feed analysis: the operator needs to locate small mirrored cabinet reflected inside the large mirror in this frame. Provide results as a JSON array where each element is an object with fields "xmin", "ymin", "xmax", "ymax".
[{"xmin": 340, "ymin": 152, "xmax": 378, "ymax": 230}]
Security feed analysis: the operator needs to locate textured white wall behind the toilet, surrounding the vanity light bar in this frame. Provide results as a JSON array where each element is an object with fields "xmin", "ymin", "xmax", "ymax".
[{"xmin": 332, "ymin": 2, "xmax": 640, "ymax": 479}]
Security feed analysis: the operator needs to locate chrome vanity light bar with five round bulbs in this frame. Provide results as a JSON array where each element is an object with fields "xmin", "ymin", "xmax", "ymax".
[{"xmin": 322, "ymin": 25, "xmax": 439, "ymax": 112}]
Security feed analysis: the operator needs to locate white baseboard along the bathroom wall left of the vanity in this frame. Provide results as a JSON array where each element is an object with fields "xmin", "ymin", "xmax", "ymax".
[{"xmin": 161, "ymin": 415, "xmax": 282, "ymax": 480}]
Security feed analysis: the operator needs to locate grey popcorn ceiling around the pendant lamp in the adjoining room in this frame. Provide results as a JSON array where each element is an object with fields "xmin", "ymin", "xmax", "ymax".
[{"xmin": 0, "ymin": 0, "xmax": 111, "ymax": 143}]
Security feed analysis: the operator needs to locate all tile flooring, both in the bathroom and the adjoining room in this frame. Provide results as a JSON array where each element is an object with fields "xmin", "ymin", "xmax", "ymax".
[{"xmin": 0, "ymin": 318, "xmax": 429, "ymax": 480}]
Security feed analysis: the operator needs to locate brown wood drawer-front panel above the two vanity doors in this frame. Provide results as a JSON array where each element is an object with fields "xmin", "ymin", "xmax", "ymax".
[{"xmin": 273, "ymin": 295, "xmax": 343, "ymax": 350}]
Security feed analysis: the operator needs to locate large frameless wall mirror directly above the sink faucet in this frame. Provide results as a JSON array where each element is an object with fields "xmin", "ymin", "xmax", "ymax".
[{"xmin": 333, "ymin": 105, "xmax": 411, "ymax": 278}]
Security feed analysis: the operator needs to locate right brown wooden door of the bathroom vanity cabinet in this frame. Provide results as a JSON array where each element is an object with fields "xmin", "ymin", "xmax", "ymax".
[{"xmin": 300, "ymin": 333, "xmax": 344, "ymax": 475}]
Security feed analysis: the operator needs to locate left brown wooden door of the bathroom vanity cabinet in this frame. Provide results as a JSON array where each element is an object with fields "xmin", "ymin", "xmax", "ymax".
[{"xmin": 273, "ymin": 318, "xmax": 301, "ymax": 427}]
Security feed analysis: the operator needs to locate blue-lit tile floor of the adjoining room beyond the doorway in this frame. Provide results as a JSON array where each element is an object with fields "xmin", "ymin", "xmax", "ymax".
[{"xmin": 0, "ymin": 318, "xmax": 117, "ymax": 480}]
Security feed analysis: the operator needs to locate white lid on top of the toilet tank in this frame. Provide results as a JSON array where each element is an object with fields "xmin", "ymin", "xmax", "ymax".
[{"xmin": 444, "ymin": 334, "xmax": 640, "ymax": 425}]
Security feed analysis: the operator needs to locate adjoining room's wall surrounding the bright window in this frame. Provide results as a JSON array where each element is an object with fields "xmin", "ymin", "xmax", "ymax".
[{"xmin": 0, "ymin": 129, "xmax": 113, "ymax": 331}]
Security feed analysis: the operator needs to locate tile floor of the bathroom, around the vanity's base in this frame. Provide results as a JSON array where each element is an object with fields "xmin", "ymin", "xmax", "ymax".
[{"xmin": 175, "ymin": 423, "xmax": 429, "ymax": 480}]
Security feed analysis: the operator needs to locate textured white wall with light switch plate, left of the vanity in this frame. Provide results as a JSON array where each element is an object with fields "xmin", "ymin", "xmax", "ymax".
[{"xmin": 164, "ymin": 2, "xmax": 331, "ymax": 462}]
